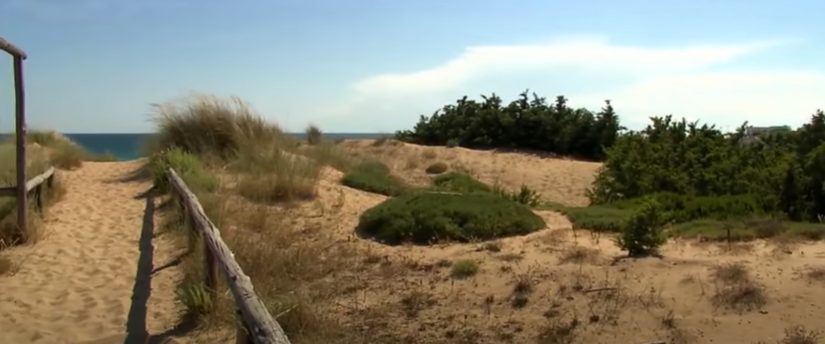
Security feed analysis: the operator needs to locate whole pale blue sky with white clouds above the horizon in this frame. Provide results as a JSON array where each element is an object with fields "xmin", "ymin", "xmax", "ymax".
[{"xmin": 0, "ymin": 0, "xmax": 825, "ymax": 133}]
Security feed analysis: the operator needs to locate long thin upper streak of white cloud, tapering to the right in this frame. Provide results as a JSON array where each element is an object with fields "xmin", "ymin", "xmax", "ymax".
[{"xmin": 353, "ymin": 37, "xmax": 779, "ymax": 94}]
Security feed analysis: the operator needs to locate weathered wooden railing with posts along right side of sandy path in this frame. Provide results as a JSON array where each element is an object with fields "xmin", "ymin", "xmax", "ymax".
[{"xmin": 168, "ymin": 168, "xmax": 290, "ymax": 344}]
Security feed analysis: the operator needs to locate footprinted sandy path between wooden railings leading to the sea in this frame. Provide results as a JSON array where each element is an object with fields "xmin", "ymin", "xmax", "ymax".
[{"xmin": 0, "ymin": 162, "xmax": 179, "ymax": 344}]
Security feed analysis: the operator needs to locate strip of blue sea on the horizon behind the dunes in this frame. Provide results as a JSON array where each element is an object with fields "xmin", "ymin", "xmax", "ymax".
[{"xmin": 0, "ymin": 133, "xmax": 391, "ymax": 160}]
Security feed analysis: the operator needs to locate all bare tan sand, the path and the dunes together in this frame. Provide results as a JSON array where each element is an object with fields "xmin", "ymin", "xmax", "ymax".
[{"xmin": 11, "ymin": 142, "xmax": 825, "ymax": 344}]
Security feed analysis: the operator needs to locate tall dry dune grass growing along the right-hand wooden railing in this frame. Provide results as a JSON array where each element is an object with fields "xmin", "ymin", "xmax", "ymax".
[{"xmin": 148, "ymin": 95, "xmax": 368, "ymax": 344}]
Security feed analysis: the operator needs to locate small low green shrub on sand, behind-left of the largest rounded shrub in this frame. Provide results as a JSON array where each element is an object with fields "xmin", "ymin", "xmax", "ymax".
[{"xmin": 341, "ymin": 161, "xmax": 405, "ymax": 196}]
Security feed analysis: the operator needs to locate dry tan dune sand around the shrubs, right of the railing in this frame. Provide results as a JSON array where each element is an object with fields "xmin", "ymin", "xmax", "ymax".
[{"xmin": 227, "ymin": 141, "xmax": 825, "ymax": 344}]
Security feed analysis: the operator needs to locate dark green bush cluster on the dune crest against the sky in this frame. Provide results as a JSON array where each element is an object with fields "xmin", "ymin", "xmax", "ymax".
[{"xmin": 396, "ymin": 91, "xmax": 621, "ymax": 160}]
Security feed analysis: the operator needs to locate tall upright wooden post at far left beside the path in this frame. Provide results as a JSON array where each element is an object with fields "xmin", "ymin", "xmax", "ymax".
[{"xmin": 14, "ymin": 55, "xmax": 29, "ymax": 235}]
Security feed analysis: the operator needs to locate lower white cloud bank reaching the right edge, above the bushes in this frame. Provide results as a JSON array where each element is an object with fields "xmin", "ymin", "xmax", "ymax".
[{"xmin": 570, "ymin": 71, "xmax": 825, "ymax": 126}]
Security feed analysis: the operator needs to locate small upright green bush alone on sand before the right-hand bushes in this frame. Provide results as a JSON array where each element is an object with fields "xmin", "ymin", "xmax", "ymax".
[{"xmin": 616, "ymin": 199, "xmax": 667, "ymax": 257}]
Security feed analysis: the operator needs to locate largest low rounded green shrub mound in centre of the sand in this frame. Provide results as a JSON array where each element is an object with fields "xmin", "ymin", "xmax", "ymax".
[{"xmin": 357, "ymin": 193, "xmax": 545, "ymax": 245}]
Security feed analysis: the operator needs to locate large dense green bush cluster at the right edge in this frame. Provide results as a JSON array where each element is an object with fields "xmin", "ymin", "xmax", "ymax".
[{"xmin": 589, "ymin": 111, "xmax": 825, "ymax": 222}]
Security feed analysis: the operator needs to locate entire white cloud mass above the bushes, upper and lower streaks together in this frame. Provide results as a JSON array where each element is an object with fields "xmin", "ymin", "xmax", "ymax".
[{"xmin": 324, "ymin": 37, "xmax": 825, "ymax": 127}]
